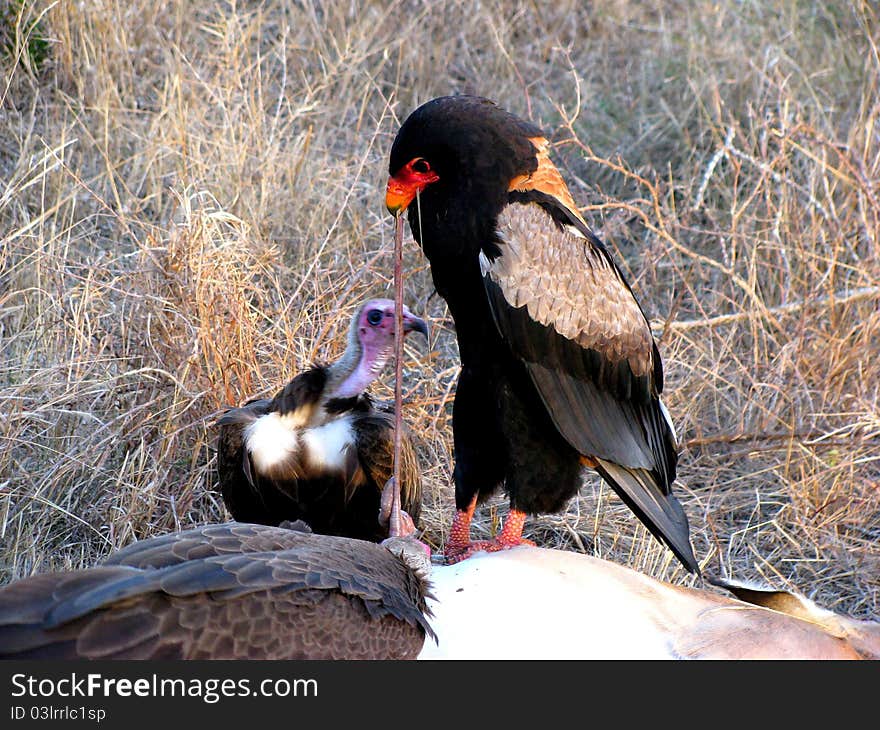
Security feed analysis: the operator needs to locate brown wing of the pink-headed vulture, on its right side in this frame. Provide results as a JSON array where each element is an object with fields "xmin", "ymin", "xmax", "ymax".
[{"xmin": 352, "ymin": 404, "xmax": 422, "ymax": 526}]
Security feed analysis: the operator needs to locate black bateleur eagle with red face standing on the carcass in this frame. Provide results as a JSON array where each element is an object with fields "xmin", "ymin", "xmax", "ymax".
[{"xmin": 385, "ymin": 95, "xmax": 699, "ymax": 574}]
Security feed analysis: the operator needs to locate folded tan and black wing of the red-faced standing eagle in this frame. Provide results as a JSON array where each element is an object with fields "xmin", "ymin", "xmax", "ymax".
[{"xmin": 480, "ymin": 198, "xmax": 696, "ymax": 569}]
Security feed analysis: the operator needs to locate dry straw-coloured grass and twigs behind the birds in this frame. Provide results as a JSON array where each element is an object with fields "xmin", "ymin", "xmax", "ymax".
[{"xmin": 0, "ymin": 0, "xmax": 880, "ymax": 618}]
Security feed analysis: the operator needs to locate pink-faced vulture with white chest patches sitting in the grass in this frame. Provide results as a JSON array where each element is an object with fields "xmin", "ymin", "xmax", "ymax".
[{"xmin": 217, "ymin": 299, "xmax": 428, "ymax": 542}]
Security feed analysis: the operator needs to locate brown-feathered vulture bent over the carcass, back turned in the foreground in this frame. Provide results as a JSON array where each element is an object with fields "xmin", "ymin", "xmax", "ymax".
[{"xmin": 0, "ymin": 522, "xmax": 434, "ymax": 659}]
